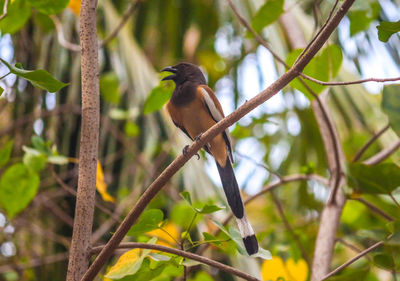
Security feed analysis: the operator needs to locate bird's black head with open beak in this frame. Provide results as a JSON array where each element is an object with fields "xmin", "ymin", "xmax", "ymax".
[{"xmin": 161, "ymin": 62, "xmax": 206, "ymax": 85}]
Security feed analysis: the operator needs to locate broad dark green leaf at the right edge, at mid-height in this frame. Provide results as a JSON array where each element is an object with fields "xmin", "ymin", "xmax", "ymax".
[{"xmin": 347, "ymin": 163, "xmax": 400, "ymax": 194}]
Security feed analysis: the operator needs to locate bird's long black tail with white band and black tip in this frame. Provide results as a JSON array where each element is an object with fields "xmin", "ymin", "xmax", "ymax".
[{"xmin": 215, "ymin": 159, "xmax": 258, "ymax": 255}]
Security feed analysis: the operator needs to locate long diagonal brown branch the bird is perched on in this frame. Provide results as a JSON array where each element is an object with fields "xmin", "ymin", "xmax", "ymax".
[{"xmin": 82, "ymin": 0, "xmax": 354, "ymax": 281}]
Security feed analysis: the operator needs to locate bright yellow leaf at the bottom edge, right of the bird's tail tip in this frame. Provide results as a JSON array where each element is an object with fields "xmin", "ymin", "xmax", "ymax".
[{"xmin": 261, "ymin": 256, "xmax": 308, "ymax": 281}]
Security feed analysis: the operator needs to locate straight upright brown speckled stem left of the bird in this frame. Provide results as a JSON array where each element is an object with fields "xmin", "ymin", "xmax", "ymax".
[{"xmin": 67, "ymin": 0, "xmax": 100, "ymax": 281}]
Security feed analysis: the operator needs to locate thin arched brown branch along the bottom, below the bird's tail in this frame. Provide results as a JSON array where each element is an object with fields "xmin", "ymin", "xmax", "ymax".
[{"xmin": 91, "ymin": 242, "xmax": 260, "ymax": 281}]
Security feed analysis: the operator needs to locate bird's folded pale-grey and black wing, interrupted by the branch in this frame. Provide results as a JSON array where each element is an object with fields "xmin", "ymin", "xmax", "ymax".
[{"xmin": 198, "ymin": 85, "xmax": 233, "ymax": 163}]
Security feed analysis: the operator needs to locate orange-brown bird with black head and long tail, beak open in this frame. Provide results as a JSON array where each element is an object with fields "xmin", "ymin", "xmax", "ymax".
[{"xmin": 161, "ymin": 62, "xmax": 258, "ymax": 255}]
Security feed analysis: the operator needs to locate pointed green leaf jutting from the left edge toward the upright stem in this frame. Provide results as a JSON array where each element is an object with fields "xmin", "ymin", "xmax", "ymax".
[{"xmin": 0, "ymin": 59, "xmax": 68, "ymax": 93}]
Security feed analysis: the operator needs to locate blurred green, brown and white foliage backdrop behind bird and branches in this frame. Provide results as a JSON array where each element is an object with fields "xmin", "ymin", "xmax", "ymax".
[{"xmin": 0, "ymin": 0, "xmax": 400, "ymax": 280}]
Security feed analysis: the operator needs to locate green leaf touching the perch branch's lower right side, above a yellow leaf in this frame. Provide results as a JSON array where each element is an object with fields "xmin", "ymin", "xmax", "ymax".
[{"xmin": 127, "ymin": 209, "xmax": 164, "ymax": 236}]
